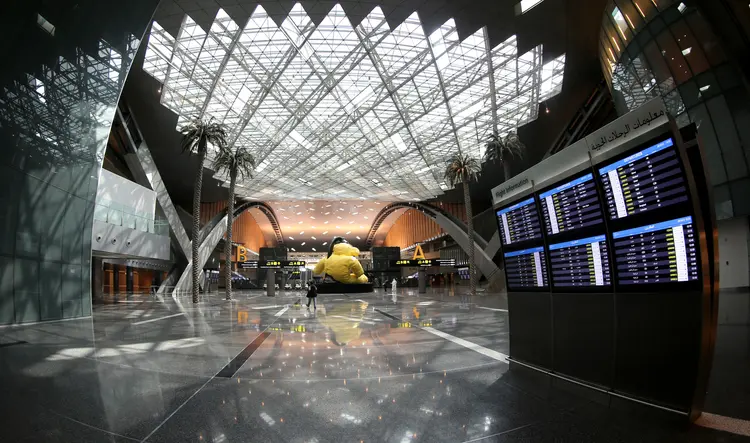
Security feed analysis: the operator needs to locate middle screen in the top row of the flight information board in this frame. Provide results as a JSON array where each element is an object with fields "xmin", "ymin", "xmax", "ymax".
[{"xmin": 539, "ymin": 174, "xmax": 604, "ymax": 235}]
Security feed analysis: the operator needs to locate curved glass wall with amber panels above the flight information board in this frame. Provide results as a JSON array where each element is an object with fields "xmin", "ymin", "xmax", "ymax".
[{"xmin": 600, "ymin": 0, "xmax": 750, "ymax": 219}]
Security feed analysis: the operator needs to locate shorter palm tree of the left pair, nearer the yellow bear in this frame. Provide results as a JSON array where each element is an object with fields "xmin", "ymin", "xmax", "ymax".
[{"xmin": 214, "ymin": 147, "xmax": 255, "ymax": 300}]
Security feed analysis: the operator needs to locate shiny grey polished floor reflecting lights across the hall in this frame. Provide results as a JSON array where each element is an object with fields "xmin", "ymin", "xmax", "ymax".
[{"xmin": 0, "ymin": 289, "xmax": 750, "ymax": 443}]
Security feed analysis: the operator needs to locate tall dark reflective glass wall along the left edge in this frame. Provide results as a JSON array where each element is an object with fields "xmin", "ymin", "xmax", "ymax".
[{"xmin": 0, "ymin": 0, "xmax": 157, "ymax": 324}]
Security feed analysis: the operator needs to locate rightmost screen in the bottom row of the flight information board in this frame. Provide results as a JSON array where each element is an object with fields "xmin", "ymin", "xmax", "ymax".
[{"xmin": 612, "ymin": 217, "xmax": 698, "ymax": 285}]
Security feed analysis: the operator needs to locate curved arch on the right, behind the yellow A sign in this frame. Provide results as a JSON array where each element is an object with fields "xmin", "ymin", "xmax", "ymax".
[{"xmin": 366, "ymin": 202, "xmax": 502, "ymax": 281}]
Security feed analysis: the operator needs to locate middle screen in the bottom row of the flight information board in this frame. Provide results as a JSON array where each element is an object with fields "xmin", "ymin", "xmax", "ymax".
[{"xmin": 549, "ymin": 235, "xmax": 612, "ymax": 287}]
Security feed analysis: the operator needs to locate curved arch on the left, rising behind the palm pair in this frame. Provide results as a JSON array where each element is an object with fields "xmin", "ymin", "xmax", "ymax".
[{"xmin": 172, "ymin": 201, "xmax": 284, "ymax": 296}]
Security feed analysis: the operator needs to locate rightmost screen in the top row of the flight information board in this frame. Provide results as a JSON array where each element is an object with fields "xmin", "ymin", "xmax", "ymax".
[{"xmin": 599, "ymin": 139, "xmax": 688, "ymax": 219}]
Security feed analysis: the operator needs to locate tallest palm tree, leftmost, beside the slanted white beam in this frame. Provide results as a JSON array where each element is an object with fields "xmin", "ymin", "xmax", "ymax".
[{"xmin": 180, "ymin": 117, "xmax": 227, "ymax": 303}]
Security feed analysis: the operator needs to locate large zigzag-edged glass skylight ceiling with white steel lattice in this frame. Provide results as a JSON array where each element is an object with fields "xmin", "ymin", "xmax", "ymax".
[{"xmin": 143, "ymin": 3, "xmax": 565, "ymax": 201}]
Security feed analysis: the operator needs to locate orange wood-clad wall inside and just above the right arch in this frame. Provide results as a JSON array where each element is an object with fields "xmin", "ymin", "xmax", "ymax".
[{"xmin": 384, "ymin": 203, "xmax": 466, "ymax": 249}]
